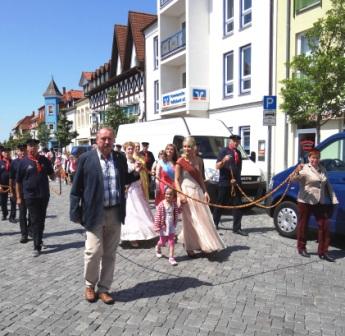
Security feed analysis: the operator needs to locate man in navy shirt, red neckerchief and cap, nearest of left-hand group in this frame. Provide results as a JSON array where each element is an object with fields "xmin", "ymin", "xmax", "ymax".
[{"xmin": 16, "ymin": 139, "xmax": 55, "ymax": 257}]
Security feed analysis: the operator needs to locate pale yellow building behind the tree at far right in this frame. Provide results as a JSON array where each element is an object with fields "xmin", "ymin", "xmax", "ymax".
[{"xmin": 272, "ymin": 0, "xmax": 344, "ymax": 172}]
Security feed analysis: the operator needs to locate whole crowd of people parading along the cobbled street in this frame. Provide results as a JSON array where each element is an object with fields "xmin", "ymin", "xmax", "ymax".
[{"xmin": 0, "ymin": 127, "xmax": 336, "ymax": 304}]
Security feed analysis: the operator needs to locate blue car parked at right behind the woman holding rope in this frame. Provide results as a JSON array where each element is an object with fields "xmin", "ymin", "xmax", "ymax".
[{"xmin": 267, "ymin": 132, "xmax": 345, "ymax": 237}]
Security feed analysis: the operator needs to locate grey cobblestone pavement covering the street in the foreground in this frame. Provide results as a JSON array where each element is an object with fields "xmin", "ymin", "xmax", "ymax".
[{"xmin": 0, "ymin": 184, "xmax": 345, "ymax": 336}]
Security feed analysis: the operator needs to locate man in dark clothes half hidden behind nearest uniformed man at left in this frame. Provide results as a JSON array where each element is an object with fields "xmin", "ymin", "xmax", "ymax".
[{"xmin": 10, "ymin": 144, "xmax": 31, "ymax": 244}]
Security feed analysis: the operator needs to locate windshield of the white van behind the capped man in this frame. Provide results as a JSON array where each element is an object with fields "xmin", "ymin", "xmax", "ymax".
[{"xmin": 194, "ymin": 136, "xmax": 248, "ymax": 160}]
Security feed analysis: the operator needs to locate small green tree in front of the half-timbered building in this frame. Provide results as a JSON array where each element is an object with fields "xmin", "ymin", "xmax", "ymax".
[{"xmin": 102, "ymin": 90, "xmax": 137, "ymax": 134}]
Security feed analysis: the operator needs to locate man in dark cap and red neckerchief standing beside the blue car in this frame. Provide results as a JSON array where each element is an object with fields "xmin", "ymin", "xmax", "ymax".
[{"xmin": 213, "ymin": 135, "xmax": 248, "ymax": 236}]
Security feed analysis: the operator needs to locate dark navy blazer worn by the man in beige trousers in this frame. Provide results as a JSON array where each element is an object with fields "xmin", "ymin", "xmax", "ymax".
[{"xmin": 70, "ymin": 150, "xmax": 139, "ymax": 230}]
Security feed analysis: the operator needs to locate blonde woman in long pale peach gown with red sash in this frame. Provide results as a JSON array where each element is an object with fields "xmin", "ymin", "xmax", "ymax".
[{"xmin": 175, "ymin": 137, "xmax": 225, "ymax": 257}]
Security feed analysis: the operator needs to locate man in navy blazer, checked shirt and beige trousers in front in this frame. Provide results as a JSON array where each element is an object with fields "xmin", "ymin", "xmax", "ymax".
[{"xmin": 70, "ymin": 127, "xmax": 141, "ymax": 304}]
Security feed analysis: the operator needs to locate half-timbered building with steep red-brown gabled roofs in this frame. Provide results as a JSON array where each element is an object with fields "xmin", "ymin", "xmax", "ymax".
[{"xmin": 83, "ymin": 11, "xmax": 156, "ymax": 124}]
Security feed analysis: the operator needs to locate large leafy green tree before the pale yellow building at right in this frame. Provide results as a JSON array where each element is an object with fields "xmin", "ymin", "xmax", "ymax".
[{"xmin": 281, "ymin": 0, "xmax": 345, "ymax": 143}]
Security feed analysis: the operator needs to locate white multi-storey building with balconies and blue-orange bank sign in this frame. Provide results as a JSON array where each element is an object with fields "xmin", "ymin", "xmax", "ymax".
[{"xmin": 145, "ymin": 0, "xmax": 274, "ymax": 177}]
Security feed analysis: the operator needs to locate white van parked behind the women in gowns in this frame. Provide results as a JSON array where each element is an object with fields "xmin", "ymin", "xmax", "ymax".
[{"xmin": 116, "ymin": 117, "xmax": 266, "ymax": 200}]
